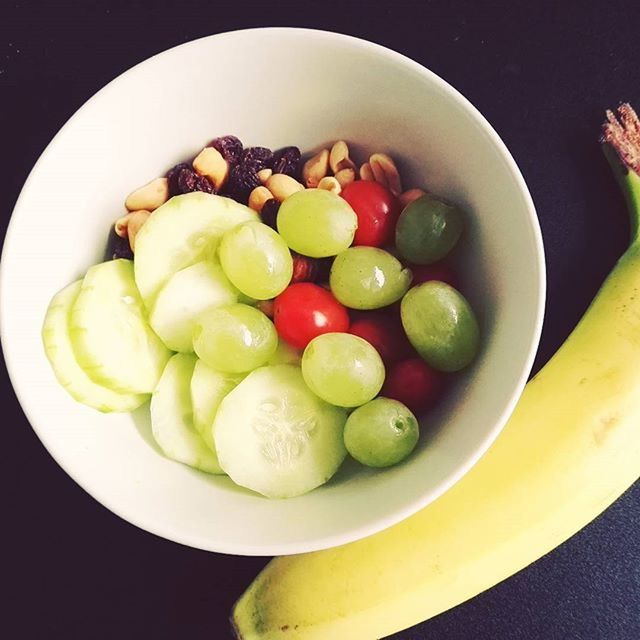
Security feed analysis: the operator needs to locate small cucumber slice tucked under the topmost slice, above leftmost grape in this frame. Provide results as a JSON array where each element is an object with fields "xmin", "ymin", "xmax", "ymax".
[{"xmin": 149, "ymin": 260, "xmax": 239, "ymax": 352}]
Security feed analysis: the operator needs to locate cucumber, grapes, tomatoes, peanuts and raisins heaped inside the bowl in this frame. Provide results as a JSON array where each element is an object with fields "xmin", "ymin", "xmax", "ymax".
[{"xmin": 42, "ymin": 135, "xmax": 480, "ymax": 498}]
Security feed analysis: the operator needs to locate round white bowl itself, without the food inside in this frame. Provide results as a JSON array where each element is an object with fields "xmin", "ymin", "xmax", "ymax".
[{"xmin": 0, "ymin": 28, "xmax": 545, "ymax": 555}]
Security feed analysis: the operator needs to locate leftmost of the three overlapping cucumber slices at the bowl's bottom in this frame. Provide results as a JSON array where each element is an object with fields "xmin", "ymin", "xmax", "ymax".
[{"xmin": 151, "ymin": 353, "xmax": 222, "ymax": 473}]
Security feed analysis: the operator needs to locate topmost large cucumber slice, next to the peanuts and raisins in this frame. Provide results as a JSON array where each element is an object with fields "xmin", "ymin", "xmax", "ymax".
[{"xmin": 134, "ymin": 191, "xmax": 258, "ymax": 307}]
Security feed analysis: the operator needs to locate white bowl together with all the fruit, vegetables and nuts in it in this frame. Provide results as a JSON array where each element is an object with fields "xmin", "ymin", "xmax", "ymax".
[{"xmin": 0, "ymin": 28, "xmax": 544, "ymax": 555}]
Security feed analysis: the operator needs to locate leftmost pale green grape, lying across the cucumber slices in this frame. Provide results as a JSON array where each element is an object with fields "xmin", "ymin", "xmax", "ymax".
[{"xmin": 193, "ymin": 304, "xmax": 278, "ymax": 373}]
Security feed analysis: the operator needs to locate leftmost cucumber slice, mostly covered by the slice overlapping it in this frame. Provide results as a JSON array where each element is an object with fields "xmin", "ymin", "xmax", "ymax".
[{"xmin": 42, "ymin": 280, "xmax": 149, "ymax": 413}]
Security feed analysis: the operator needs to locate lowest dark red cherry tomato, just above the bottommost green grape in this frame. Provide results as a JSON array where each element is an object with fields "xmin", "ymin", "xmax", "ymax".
[{"xmin": 380, "ymin": 358, "xmax": 444, "ymax": 414}]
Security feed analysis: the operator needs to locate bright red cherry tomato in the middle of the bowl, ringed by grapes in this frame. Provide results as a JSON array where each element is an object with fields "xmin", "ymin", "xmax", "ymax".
[{"xmin": 273, "ymin": 282, "xmax": 349, "ymax": 349}]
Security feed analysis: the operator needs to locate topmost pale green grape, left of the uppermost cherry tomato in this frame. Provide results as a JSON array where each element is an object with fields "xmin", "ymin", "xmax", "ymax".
[{"xmin": 277, "ymin": 189, "xmax": 358, "ymax": 258}]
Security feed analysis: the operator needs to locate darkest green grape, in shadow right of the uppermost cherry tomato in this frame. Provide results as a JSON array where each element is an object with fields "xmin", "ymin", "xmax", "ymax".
[{"xmin": 396, "ymin": 194, "xmax": 464, "ymax": 264}]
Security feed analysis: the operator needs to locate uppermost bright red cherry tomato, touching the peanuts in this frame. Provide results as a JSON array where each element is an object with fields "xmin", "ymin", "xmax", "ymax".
[{"xmin": 340, "ymin": 180, "xmax": 400, "ymax": 247}]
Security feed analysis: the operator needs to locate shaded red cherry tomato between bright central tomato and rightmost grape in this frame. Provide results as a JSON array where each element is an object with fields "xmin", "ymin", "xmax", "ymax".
[{"xmin": 349, "ymin": 309, "xmax": 415, "ymax": 365}]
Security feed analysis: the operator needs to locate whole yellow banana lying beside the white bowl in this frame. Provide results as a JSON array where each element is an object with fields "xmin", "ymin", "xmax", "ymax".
[{"xmin": 232, "ymin": 105, "xmax": 640, "ymax": 640}]
